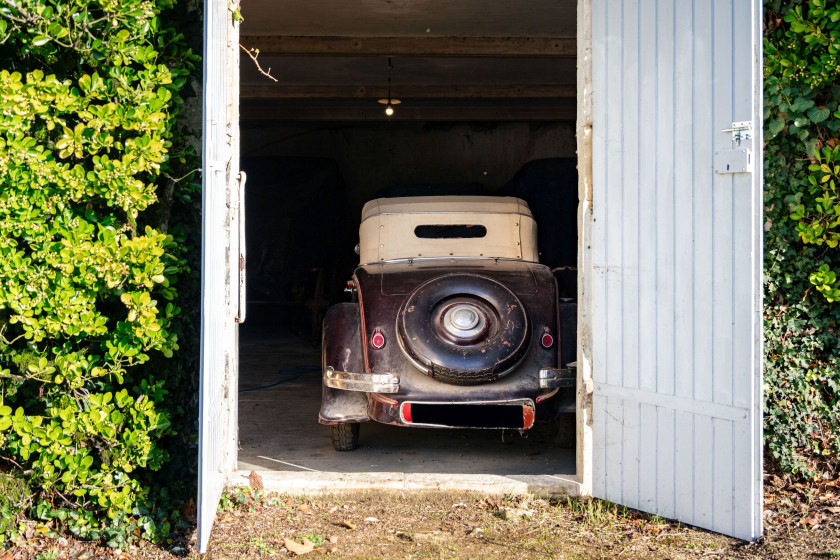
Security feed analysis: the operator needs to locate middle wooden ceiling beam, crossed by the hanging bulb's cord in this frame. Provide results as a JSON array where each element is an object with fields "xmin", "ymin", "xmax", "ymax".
[{"xmin": 239, "ymin": 84, "xmax": 577, "ymax": 100}]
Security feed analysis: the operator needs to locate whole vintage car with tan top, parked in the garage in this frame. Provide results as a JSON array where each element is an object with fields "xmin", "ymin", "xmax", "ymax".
[{"xmin": 319, "ymin": 196, "xmax": 576, "ymax": 451}]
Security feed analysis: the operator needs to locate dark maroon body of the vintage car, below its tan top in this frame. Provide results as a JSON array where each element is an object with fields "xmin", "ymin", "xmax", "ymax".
[{"xmin": 319, "ymin": 197, "xmax": 576, "ymax": 450}]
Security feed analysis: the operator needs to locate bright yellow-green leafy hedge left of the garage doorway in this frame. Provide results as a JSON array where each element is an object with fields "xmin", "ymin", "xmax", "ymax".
[{"xmin": 0, "ymin": 0, "xmax": 198, "ymax": 544}]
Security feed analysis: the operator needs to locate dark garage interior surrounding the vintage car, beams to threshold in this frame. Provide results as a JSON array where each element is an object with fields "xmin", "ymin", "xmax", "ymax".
[{"xmin": 238, "ymin": 0, "xmax": 577, "ymax": 492}]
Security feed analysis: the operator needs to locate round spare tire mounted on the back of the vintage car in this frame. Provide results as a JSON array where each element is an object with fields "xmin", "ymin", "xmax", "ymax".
[{"xmin": 397, "ymin": 274, "xmax": 530, "ymax": 385}]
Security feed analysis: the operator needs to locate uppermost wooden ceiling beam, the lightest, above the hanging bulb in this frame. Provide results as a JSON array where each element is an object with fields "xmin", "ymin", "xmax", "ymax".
[{"xmin": 239, "ymin": 35, "xmax": 577, "ymax": 58}]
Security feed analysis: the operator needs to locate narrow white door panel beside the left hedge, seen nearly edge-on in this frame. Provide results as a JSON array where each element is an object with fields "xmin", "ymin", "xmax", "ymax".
[{"xmin": 197, "ymin": 0, "xmax": 244, "ymax": 553}]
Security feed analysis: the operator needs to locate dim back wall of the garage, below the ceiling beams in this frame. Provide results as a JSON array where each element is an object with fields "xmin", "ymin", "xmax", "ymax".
[{"xmin": 242, "ymin": 122, "xmax": 575, "ymax": 212}]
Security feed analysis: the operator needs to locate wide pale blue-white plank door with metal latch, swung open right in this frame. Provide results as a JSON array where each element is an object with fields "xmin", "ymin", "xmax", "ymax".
[{"xmin": 587, "ymin": 0, "xmax": 762, "ymax": 539}]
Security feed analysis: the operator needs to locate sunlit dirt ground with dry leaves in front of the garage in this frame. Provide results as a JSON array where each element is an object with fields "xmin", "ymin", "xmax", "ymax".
[{"xmin": 0, "ymin": 475, "xmax": 840, "ymax": 560}]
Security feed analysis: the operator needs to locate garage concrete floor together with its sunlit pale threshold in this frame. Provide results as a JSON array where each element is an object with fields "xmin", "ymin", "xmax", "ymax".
[{"xmin": 234, "ymin": 328, "xmax": 579, "ymax": 494}]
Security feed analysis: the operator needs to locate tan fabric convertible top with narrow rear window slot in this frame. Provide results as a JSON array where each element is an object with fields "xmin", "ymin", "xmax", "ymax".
[{"xmin": 359, "ymin": 196, "xmax": 539, "ymax": 264}]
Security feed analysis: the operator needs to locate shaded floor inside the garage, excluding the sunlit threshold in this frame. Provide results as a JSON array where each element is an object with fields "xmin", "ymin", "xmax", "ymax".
[{"xmin": 239, "ymin": 329, "xmax": 575, "ymax": 476}]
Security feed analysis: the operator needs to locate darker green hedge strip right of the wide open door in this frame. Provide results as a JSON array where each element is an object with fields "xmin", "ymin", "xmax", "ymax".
[{"xmin": 764, "ymin": 0, "xmax": 840, "ymax": 478}]
